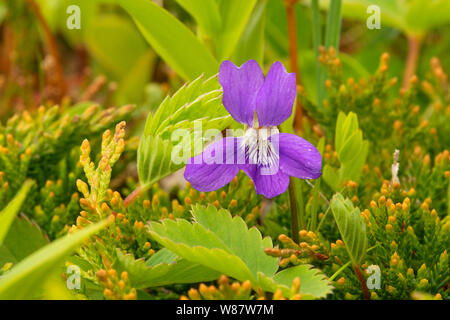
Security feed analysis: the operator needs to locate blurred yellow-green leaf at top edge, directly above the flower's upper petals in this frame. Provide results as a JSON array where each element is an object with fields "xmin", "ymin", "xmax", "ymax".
[{"xmin": 215, "ymin": 0, "xmax": 256, "ymax": 61}]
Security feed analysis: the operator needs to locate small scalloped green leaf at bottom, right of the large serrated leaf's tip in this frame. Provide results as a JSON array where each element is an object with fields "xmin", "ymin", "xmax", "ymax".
[{"xmin": 260, "ymin": 265, "xmax": 332, "ymax": 299}]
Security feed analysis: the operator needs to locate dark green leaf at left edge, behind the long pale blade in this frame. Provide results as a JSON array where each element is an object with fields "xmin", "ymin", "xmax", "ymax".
[{"xmin": 0, "ymin": 215, "xmax": 48, "ymax": 266}]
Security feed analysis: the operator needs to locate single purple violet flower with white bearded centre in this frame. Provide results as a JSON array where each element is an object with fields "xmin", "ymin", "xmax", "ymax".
[{"xmin": 184, "ymin": 60, "xmax": 322, "ymax": 198}]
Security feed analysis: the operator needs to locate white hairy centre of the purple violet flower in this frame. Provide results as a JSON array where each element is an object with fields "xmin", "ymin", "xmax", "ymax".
[{"xmin": 241, "ymin": 127, "xmax": 279, "ymax": 167}]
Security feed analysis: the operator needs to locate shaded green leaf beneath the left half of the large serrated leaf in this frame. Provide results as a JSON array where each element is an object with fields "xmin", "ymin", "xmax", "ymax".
[{"xmin": 117, "ymin": 249, "xmax": 220, "ymax": 289}]
